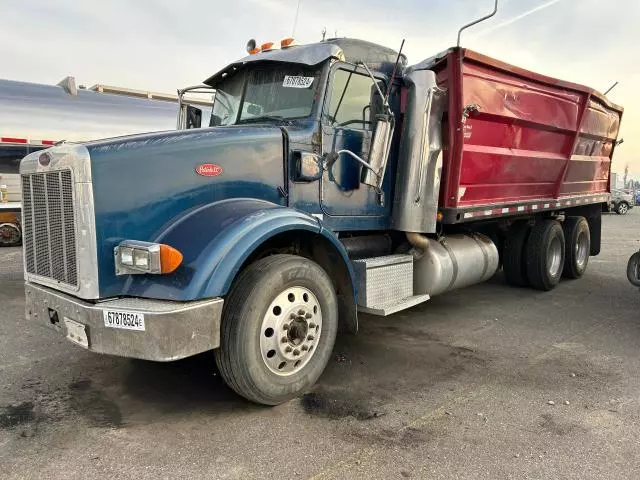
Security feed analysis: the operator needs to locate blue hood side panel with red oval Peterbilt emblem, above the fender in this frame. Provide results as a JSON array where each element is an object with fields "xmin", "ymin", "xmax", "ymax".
[{"xmin": 85, "ymin": 125, "xmax": 284, "ymax": 297}]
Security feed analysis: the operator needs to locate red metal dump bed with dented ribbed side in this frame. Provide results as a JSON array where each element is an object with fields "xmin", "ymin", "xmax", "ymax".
[{"xmin": 430, "ymin": 49, "xmax": 623, "ymax": 223}]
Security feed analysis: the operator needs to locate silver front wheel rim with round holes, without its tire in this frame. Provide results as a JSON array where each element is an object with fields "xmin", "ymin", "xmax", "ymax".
[{"xmin": 260, "ymin": 287, "xmax": 322, "ymax": 376}]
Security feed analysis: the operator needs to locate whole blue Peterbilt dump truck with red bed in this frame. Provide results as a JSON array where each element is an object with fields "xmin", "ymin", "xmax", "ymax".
[{"xmin": 20, "ymin": 39, "xmax": 622, "ymax": 405}]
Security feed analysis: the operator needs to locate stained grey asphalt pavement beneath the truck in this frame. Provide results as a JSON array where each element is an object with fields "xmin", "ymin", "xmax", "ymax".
[{"xmin": 0, "ymin": 212, "xmax": 640, "ymax": 480}]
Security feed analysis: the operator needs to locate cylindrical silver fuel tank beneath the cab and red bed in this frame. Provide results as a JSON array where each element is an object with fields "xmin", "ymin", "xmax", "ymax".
[{"xmin": 413, "ymin": 233, "xmax": 499, "ymax": 297}]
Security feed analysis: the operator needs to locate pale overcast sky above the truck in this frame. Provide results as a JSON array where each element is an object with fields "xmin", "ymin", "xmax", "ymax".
[{"xmin": 0, "ymin": 0, "xmax": 640, "ymax": 174}]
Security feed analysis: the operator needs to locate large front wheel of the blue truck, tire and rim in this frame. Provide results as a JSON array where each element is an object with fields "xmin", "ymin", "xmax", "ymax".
[{"xmin": 216, "ymin": 255, "xmax": 338, "ymax": 405}]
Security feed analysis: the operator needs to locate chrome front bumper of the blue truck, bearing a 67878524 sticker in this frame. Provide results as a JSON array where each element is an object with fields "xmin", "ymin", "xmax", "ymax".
[{"xmin": 25, "ymin": 282, "xmax": 223, "ymax": 362}]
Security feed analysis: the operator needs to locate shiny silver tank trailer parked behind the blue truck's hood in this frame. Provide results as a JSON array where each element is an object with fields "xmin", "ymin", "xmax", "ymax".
[{"xmin": 0, "ymin": 77, "xmax": 210, "ymax": 246}]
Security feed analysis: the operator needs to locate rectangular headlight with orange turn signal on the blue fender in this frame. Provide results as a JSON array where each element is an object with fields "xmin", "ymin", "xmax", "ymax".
[{"xmin": 113, "ymin": 240, "xmax": 182, "ymax": 275}]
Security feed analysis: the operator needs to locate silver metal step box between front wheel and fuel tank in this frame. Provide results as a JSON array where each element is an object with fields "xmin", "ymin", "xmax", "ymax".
[{"xmin": 353, "ymin": 254, "xmax": 430, "ymax": 316}]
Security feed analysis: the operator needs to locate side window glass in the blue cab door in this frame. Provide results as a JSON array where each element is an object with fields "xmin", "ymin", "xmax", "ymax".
[{"xmin": 326, "ymin": 70, "xmax": 384, "ymax": 130}]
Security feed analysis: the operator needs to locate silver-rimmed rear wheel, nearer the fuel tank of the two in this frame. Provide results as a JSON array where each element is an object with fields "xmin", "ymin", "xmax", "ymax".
[{"xmin": 526, "ymin": 220, "xmax": 565, "ymax": 291}]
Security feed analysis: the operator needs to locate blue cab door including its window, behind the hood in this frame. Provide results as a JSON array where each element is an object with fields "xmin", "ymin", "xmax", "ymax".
[{"xmin": 320, "ymin": 63, "xmax": 390, "ymax": 230}]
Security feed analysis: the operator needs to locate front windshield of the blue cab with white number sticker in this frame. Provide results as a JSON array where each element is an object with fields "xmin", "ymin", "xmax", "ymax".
[{"xmin": 210, "ymin": 64, "xmax": 320, "ymax": 126}]
